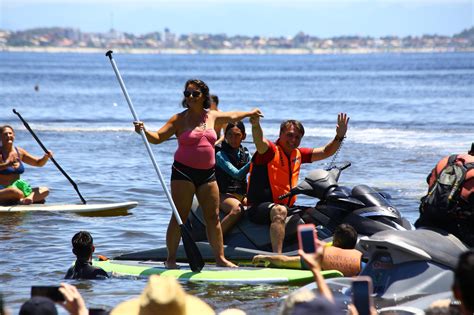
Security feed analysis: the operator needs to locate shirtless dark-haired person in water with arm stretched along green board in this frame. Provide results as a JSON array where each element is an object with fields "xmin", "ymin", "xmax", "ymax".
[{"xmin": 252, "ymin": 224, "xmax": 363, "ymax": 277}]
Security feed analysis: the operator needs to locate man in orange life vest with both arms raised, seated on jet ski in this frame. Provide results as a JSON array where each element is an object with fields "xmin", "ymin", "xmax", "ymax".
[{"xmin": 247, "ymin": 113, "xmax": 349, "ymax": 253}]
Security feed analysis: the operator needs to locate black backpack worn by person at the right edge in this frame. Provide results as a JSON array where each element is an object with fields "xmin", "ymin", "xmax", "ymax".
[{"xmin": 420, "ymin": 155, "xmax": 474, "ymax": 220}]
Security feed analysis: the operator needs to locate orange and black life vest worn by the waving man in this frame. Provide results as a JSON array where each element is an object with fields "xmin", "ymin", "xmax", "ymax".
[{"xmin": 248, "ymin": 144, "xmax": 301, "ymax": 207}]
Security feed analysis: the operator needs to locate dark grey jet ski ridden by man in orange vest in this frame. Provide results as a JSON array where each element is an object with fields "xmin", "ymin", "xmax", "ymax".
[{"xmin": 115, "ymin": 163, "xmax": 413, "ymax": 262}]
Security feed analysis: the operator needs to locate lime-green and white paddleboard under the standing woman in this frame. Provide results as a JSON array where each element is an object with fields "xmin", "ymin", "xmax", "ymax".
[{"xmin": 92, "ymin": 260, "xmax": 343, "ymax": 285}]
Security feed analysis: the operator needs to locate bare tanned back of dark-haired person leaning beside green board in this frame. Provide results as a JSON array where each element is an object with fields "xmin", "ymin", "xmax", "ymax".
[{"xmin": 321, "ymin": 246, "xmax": 362, "ymax": 277}]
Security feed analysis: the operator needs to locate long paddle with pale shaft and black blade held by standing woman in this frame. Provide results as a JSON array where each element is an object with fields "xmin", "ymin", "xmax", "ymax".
[{"xmin": 105, "ymin": 50, "xmax": 204, "ymax": 272}]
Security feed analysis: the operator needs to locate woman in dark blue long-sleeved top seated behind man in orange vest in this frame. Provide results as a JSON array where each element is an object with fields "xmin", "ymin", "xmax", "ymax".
[{"xmin": 216, "ymin": 121, "xmax": 250, "ymax": 235}]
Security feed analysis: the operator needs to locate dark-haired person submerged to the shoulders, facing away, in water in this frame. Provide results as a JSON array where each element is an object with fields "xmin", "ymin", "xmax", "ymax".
[{"xmin": 64, "ymin": 231, "xmax": 109, "ymax": 279}]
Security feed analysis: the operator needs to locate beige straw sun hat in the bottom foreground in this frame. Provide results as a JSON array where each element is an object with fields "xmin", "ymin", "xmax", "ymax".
[{"xmin": 110, "ymin": 275, "xmax": 215, "ymax": 315}]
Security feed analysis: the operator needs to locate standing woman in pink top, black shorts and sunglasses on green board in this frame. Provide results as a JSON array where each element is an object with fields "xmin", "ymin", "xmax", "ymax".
[{"xmin": 134, "ymin": 79, "xmax": 262, "ymax": 268}]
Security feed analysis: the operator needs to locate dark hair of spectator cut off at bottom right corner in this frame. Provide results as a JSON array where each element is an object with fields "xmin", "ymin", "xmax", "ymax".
[{"xmin": 453, "ymin": 249, "xmax": 474, "ymax": 313}]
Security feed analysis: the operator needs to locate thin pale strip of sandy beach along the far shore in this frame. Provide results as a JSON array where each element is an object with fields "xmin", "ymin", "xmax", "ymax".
[{"xmin": 0, "ymin": 46, "xmax": 474, "ymax": 55}]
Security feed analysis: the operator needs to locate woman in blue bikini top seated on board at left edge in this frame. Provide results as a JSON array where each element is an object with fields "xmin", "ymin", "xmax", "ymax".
[{"xmin": 0, "ymin": 125, "xmax": 53, "ymax": 205}]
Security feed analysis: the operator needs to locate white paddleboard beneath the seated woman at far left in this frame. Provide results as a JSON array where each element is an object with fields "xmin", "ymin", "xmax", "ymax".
[{"xmin": 0, "ymin": 201, "xmax": 138, "ymax": 216}]
